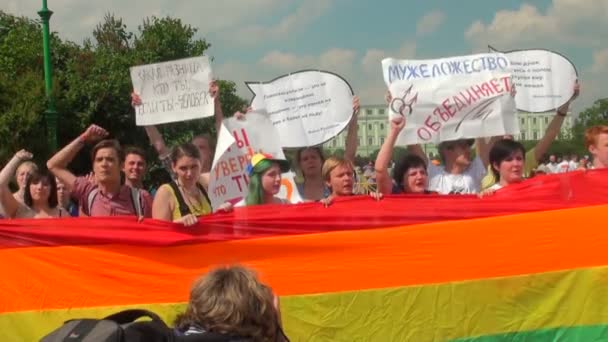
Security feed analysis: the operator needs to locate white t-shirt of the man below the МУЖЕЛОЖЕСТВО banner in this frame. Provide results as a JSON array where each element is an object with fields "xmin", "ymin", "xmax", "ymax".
[{"xmin": 428, "ymin": 157, "xmax": 487, "ymax": 195}]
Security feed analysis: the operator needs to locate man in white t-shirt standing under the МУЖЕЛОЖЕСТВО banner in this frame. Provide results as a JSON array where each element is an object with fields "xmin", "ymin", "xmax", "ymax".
[{"xmin": 410, "ymin": 139, "xmax": 488, "ymax": 195}]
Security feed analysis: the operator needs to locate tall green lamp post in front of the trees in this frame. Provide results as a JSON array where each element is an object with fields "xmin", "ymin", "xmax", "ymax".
[{"xmin": 38, "ymin": 0, "xmax": 57, "ymax": 152}]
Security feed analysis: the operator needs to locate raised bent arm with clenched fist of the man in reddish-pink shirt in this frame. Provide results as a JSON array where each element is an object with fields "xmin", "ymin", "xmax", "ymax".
[{"xmin": 46, "ymin": 125, "xmax": 108, "ymax": 187}]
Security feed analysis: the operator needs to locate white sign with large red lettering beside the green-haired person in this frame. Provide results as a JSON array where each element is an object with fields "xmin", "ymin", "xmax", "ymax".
[{"xmin": 209, "ymin": 112, "xmax": 302, "ymax": 208}]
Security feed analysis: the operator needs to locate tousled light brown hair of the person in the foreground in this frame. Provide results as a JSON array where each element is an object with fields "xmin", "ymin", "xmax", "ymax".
[{"xmin": 175, "ymin": 266, "xmax": 283, "ymax": 342}]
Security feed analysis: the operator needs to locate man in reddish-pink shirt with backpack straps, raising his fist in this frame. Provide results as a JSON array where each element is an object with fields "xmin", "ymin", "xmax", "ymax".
[{"xmin": 47, "ymin": 125, "xmax": 152, "ymax": 220}]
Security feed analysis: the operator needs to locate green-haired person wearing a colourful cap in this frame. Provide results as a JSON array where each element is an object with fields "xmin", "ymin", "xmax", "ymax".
[{"xmin": 235, "ymin": 153, "xmax": 291, "ymax": 207}]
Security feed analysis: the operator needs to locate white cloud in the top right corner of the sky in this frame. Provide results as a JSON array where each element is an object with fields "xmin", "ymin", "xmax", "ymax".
[{"xmin": 465, "ymin": 0, "xmax": 608, "ymax": 50}]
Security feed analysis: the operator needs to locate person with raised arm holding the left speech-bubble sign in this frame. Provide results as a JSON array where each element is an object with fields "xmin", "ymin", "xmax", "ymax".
[{"xmin": 296, "ymin": 96, "xmax": 359, "ymax": 201}]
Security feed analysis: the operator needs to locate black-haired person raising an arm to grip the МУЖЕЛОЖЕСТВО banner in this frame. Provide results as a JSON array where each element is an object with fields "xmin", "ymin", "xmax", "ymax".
[{"xmin": 375, "ymin": 116, "xmax": 431, "ymax": 195}]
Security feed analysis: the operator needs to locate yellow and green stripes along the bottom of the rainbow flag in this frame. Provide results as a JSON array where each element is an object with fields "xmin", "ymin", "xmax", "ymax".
[{"xmin": 0, "ymin": 267, "xmax": 608, "ymax": 342}]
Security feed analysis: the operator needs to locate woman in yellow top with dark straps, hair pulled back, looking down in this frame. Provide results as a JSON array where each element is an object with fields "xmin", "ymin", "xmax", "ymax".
[{"xmin": 152, "ymin": 143, "xmax": 232, "ymax": 227}]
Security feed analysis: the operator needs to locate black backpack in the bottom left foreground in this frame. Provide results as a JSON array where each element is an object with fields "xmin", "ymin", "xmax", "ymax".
[{"xmin": 40, "ymin": 310, "xmax": 252, "ymax": 342}]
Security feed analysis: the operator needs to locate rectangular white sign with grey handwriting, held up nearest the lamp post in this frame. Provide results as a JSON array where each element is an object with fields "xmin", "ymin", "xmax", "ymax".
[{"xmin": 130, "ymin": 56, "xmax": 214, "ymax": 126}]
